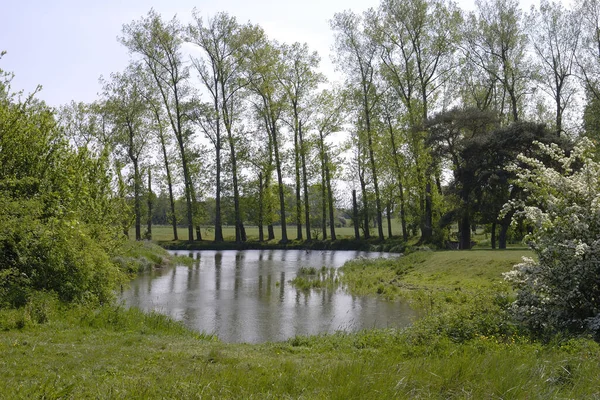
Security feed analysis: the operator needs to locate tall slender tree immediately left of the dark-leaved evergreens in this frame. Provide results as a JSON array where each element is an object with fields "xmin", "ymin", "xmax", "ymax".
[{"xmin": 376, "ymin": 0, "xmax": 462, "ymax": 242}]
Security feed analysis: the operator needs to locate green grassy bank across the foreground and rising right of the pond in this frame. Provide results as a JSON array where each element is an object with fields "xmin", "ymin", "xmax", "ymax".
[{"xmin": 0, "ymin": 251, "xmax": 600, "ymax": 399}]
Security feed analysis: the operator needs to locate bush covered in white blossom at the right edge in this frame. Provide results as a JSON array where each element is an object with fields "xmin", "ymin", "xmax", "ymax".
[{"xmin": 504, "ymin": 139, "xmax": 600, "ymax": 337}]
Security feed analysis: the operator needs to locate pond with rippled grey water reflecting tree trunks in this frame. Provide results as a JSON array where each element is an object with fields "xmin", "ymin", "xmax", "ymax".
[{"xmin": 121, "ymin": 250, "xmax": 415, "ymax": 343}]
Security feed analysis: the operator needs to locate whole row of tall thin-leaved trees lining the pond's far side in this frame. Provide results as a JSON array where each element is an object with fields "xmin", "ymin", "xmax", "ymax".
[{"xmin": 61, "ymin": 0, "xmax": 600, "ymax": 248}]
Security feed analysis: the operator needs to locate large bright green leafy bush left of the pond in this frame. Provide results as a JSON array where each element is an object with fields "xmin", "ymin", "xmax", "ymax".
[{"xmin": 0, "ymin": 68, "xmax": 122, "ymax": 307}]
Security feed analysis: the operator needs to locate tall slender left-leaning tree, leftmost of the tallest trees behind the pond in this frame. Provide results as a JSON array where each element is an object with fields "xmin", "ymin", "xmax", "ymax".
[{"xmin": 119, "ymin": 10, "xmax": 201, "ymax": 241}]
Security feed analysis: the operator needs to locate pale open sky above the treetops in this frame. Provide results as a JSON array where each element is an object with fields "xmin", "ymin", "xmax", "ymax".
[{"xmin": 0, "ymin": 0, "xmax": 531, "ymax": 107}]
